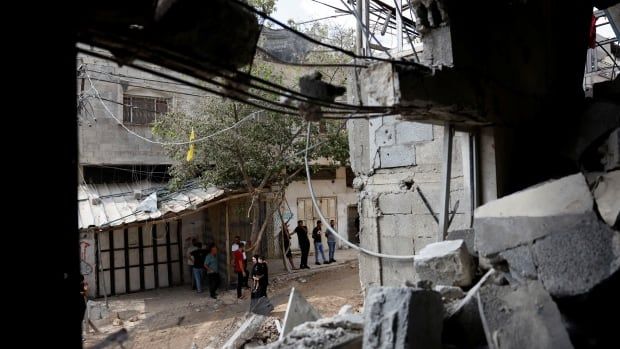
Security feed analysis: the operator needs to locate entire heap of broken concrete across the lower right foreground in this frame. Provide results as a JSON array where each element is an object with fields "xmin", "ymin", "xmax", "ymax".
[{"xmin": 228, "ymin": 171, "xmax": 620, "ymax": 349}]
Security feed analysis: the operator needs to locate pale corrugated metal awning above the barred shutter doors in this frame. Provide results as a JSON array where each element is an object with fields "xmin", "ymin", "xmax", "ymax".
[{"xmin": 77, "ymin": 181, "xmax": 224, "ymax": 229}]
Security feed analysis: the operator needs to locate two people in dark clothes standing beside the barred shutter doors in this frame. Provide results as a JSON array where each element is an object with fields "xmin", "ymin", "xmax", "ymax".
[{"xmin": 187, "ymin": 239, "xmax": 220, "ymax": 299}]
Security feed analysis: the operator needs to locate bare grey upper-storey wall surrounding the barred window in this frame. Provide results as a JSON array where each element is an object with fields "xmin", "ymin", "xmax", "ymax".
[{"xmin": 77, "ymin": 55, "xmax": 204, "ymax": 165}]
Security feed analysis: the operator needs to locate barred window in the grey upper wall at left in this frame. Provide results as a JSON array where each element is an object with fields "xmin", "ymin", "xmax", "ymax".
[{"xmin": 123, "ymin": 96, "xmax": 168, "ymax": 125}]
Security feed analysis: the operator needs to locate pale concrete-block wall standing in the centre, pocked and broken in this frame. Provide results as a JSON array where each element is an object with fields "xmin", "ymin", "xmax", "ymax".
[{"xmin": 348, "ymin": 116, "xmax": 471, "ymax": 288}]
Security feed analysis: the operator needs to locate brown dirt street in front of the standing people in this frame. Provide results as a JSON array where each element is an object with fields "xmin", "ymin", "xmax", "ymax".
[{"xmin": 84, "ymin": 256, "xmax": 363, "ymax": 349}]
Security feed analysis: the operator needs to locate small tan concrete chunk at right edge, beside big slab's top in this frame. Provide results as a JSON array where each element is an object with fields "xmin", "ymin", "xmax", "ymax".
[{"xmin": 594, "ymin": 170, "xmax": 620, "ymax": 227}]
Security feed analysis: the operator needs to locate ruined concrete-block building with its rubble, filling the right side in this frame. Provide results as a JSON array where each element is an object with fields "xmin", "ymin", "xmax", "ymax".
[{"xmin": 270, "ymin": 0, "xmax": 620, "ymax": 348}]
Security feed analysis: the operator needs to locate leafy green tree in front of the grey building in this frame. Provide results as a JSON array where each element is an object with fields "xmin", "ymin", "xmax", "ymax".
[{"xmin": 153, "ymin": 60, "xmax": 348, "ymax": 251}]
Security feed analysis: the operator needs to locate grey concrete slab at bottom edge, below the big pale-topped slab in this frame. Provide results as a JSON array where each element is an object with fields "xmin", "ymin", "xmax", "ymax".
[{"xmin": 479, "ymin": 281, "xmax": 573, "ymax": 349}]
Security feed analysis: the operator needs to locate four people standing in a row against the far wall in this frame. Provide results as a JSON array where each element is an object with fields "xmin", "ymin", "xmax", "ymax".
[{"xmin": 283, "ymin": 219, "xmax": 336, "ymax": 269}]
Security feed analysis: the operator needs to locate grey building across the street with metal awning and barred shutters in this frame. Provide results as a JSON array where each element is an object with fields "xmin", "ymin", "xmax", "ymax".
[{"xmin": 76, "ymin": 50, "xmax": 357, "ymax": 297}]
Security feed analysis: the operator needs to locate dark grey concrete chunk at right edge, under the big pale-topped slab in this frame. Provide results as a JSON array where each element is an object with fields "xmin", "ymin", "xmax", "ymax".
[{"xmin": 531, "ymin": 217, "xmax": 620, "ymax": 297}]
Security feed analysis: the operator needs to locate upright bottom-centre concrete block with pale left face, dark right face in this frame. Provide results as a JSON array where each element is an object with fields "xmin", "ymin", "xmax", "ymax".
[{"xmin": 363, "ymin": 287, "xmax": 443, "ymax": 349}]
